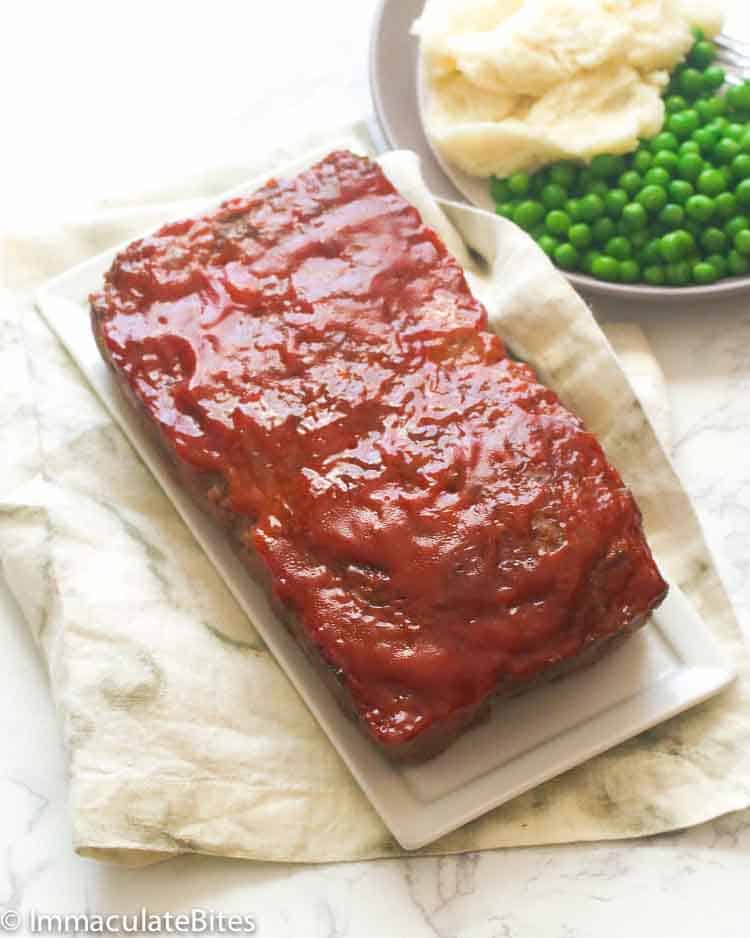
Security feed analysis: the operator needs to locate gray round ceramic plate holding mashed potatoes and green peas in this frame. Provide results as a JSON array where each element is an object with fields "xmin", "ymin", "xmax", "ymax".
[{"xmin": 370, "ymin": 0, "xmax": 750, "ymax": 302}]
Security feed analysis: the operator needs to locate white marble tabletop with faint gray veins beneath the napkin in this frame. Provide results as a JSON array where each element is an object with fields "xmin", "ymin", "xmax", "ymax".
[{"xmin": 0, "ymin": 0, "xmax": 750, "ymax": 938}]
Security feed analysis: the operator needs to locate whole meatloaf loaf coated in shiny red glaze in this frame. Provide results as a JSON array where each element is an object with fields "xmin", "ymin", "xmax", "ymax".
[{"xmin": 91, "ymin": 152, "xmax": 666, "ymax": 757}]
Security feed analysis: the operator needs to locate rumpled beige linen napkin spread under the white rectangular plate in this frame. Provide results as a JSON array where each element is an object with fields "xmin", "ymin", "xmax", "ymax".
[{"xmin": 0, "ymin": 128, "xmax": 750, "ymax": 865}]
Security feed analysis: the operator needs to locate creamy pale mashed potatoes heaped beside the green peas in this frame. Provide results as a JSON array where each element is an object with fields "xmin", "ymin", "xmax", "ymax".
[{"xmin": 414, "ymin": 0, "xmax": 722, "ymax": 176}]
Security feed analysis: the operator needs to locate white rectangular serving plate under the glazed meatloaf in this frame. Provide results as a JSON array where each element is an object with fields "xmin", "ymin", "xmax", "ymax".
[{"xmin": 37, "ymin": 165, "xmax": 734, "ymax": 850}]
